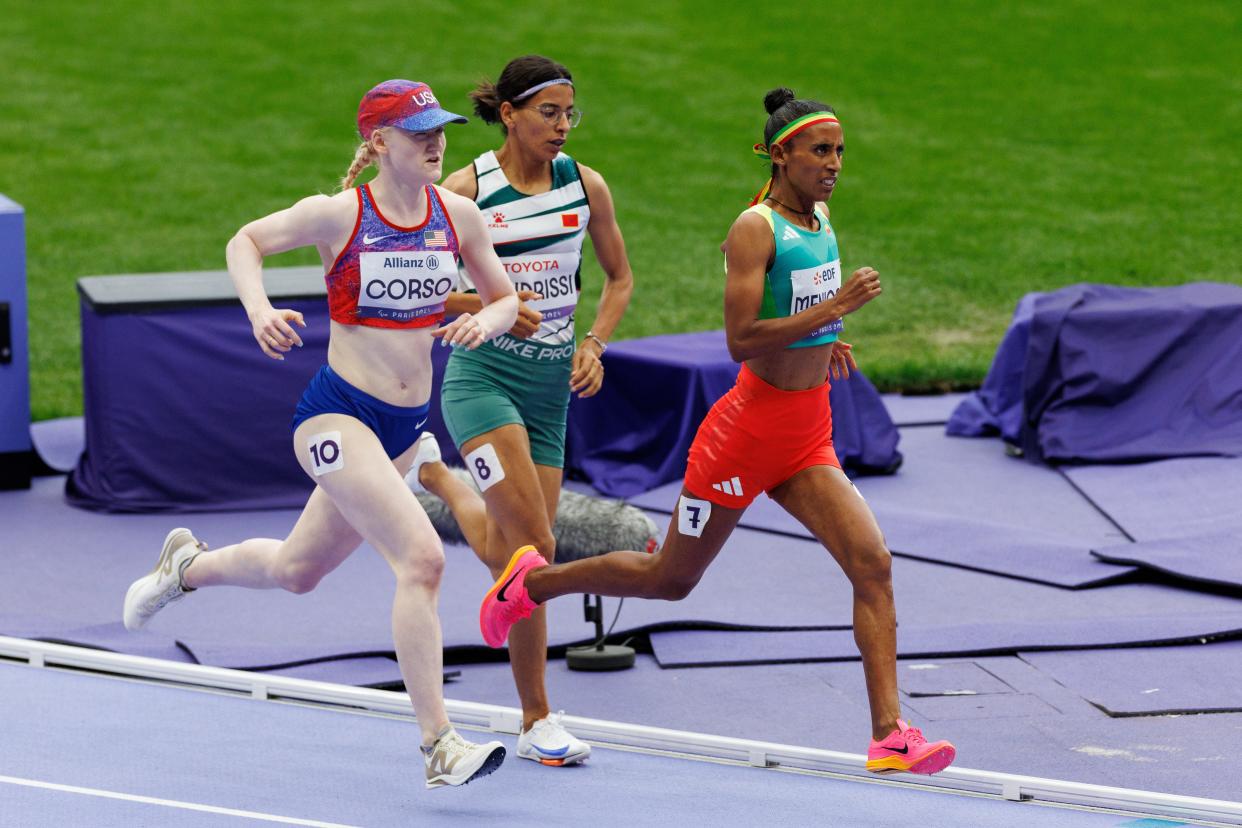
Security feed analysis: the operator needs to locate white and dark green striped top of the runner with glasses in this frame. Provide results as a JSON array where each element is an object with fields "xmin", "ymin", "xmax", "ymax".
[{"xmin": 460, "ymin": 150, "xmax": 591, "ymax": 361}]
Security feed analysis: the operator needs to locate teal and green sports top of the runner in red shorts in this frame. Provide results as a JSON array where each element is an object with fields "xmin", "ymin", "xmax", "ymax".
[{"xmin": 746, "ymin": 204, "xmax": 843, "ymax": 348}]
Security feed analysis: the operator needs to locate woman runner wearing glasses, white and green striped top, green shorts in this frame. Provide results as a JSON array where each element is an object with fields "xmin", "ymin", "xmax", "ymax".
[{"xmin": 406, "ymin": 56, "xmax": 633, "ymax": 765}]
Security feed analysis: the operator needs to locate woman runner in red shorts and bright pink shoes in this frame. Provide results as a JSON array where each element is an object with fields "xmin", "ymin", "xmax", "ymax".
[{"xmin": 479, "ymin": 89, "xmax": 955, "ymax": 773}]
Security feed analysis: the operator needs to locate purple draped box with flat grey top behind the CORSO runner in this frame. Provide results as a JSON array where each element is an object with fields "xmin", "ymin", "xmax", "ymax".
[{"xmin": 65, "ymin": 267, "xmax": 456, "ymax": 511}]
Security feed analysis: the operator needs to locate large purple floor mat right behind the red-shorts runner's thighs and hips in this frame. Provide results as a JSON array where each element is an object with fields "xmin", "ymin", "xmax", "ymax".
[{"xmin": 630, "ymin": 428, "xmax": 1134, "ymax": 588}]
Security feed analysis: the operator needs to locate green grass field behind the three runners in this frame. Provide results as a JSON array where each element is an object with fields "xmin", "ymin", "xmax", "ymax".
[{"xmin": 0, "ymin": 0, "xmax": 1242, "ymax": 418}]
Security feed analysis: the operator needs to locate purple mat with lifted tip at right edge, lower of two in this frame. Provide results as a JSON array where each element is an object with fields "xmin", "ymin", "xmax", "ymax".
[{"xmin": 1092, "ymin": 531, "xmax": 1242, "ymax": 587}]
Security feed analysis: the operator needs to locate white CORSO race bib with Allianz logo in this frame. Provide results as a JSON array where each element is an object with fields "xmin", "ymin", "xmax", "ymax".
[{"xmin": 358, "ymin": 251, "xmax": 457, "ymax": 322}]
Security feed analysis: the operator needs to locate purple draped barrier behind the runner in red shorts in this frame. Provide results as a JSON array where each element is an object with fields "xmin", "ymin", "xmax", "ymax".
[{"xmin": 565, "ymin": 330, "xmax": 902, "ymax": 498}]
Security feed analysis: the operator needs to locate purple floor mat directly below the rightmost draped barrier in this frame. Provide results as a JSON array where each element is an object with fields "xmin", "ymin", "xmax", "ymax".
[{"xmin": 1063, "ymin": 456, "xmax": 1242, "ymax": 549}]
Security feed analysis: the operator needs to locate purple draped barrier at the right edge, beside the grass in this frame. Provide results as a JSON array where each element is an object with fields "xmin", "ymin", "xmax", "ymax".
[{"xmin": 946, "ymin": 282, "xmax": 1242, "ymax": 462}]
